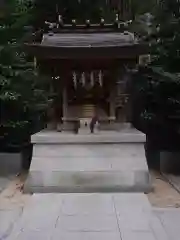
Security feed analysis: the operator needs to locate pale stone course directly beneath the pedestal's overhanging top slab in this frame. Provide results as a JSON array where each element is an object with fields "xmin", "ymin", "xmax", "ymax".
[{"xmin": 33, "ymin": 143, "xmax": 145, "ymax": 158}]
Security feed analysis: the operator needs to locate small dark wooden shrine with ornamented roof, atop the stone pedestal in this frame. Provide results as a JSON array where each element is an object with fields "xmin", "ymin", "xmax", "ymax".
[{"xmin": 26, "ymin": 2, "xmax": 147, "ymax": 130}]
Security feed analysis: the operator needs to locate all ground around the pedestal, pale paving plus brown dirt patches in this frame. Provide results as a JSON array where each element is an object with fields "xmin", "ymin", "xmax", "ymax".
[{"xmin": 0, "ymin": 172, "xmax": 180, "ymax": 240}]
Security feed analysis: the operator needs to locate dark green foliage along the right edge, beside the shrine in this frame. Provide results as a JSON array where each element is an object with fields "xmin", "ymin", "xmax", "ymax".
[{"xmin": 131, "ymin": 0, "xmax": 180, "ymax": 144}]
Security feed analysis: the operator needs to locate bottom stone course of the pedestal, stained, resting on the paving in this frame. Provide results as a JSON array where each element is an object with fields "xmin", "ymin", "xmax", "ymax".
[{"xmin": 24, "ymin": 171, "xmax": 152, "ymax": 193}]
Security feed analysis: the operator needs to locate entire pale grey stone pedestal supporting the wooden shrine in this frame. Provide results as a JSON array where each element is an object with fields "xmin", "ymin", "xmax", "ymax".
[{"xmin": 24, "ymin": 129, "xmax": 151, "ymax": 193}]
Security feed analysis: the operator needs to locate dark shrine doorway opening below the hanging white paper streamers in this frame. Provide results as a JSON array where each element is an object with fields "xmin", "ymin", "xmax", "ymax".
[{"xmin": 66, "ymin": 74, "xmax": 109, "ymax": 122}]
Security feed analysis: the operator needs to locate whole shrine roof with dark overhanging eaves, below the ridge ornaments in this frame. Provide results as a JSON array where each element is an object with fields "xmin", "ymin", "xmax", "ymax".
[{"xmin": 25, "ymin": 31, "xmax": 149, "ymax": 59}]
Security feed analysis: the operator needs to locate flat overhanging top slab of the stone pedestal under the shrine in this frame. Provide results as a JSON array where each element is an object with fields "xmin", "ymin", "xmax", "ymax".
[{"xmin": 31, "ymin": 129, "xmax": 146, "ymax": 144}]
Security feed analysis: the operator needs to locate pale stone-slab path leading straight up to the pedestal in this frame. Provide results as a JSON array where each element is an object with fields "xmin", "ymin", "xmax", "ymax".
[{"xmin": 7, "ymin": 193, "xmax": 171, "ymax": 240}]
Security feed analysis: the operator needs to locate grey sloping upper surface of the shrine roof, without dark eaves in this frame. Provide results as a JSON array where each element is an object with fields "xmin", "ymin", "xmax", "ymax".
[{"xmin": 41, "ymin": 32, "xmax": 137, "ymax": 47}]
